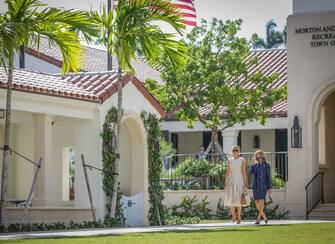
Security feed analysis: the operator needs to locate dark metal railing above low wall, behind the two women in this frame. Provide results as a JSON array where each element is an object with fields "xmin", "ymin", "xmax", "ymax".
[{"xmin": 160, "ymin": 152, "xmax": 288, "ymax": 190}]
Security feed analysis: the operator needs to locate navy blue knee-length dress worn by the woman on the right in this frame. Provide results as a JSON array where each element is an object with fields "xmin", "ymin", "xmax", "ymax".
[{"xmin": 249, "ymin": 162, "xmax": 272, "ymax": 200}]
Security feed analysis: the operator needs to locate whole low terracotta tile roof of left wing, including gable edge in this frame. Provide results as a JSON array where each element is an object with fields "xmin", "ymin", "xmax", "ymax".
[{"xmin": 0, "ymin": 68, "xmax": 165, "ymax": 116}]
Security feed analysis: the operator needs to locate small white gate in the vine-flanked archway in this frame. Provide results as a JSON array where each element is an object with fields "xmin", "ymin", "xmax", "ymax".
[{"xmin": 121, "ymin": 192, "xmax": 143, "ymax": 226}]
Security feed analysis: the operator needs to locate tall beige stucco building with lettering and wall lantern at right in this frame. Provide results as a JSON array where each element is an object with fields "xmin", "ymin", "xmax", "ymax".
[{"xmin": 287, "ymin": 0, "xmax": 335, "ymax": 216}]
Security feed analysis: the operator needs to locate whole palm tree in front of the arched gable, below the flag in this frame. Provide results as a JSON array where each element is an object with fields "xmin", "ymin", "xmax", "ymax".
[{"xmin": 93, "ymin": 0, "xmax": 185, "ymax": 218}]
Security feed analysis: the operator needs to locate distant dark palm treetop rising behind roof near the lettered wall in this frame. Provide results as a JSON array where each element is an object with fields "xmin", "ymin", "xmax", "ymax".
[{"xmin": 253, "ymin": 20, "xmax": 285, "ymax": 49}]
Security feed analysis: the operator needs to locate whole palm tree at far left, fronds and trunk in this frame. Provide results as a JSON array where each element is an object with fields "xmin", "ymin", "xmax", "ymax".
[{"xmin": 0, "ymin": 0, "xmax": 97, "ymax": 223}]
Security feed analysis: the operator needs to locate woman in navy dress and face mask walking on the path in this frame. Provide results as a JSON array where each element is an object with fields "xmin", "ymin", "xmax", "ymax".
[{"xmin": 250, "ymin": 150, "xmax": 272, "ymax": 224}]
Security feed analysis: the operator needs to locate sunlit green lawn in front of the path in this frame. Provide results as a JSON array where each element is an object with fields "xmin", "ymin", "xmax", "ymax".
[{"xmin": 2, "ymin": 223, "xmax": 335, "ymax": 244}]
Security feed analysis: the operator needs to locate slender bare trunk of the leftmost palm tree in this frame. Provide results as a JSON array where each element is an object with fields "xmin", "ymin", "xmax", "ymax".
[{"xmin": 0, "ymin": 52, "xmax": 14, "ymax": 224}]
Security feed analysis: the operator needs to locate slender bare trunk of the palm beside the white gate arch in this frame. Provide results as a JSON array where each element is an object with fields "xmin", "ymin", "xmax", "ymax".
[{"xmin": 110, "ymin": 66, "xmax": 122, "ymax": 218}]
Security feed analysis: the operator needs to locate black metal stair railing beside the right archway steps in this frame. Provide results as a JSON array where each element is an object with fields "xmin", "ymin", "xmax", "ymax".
[{"xmin": 305, "ymin": 172, "xmax": 324, "ymax": 220}]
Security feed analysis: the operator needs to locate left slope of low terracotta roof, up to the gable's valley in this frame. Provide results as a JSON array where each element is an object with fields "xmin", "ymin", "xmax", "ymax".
[{"xmin": 0, "ymin": 68, "xmax": 99, "ymax": 102}]
